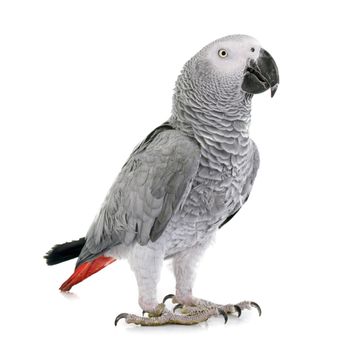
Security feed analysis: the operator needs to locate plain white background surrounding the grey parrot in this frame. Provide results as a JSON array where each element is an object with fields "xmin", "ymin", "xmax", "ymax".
[{"xmin": 0, "ymin": 0, "xmax": 350, "ymax": 349}]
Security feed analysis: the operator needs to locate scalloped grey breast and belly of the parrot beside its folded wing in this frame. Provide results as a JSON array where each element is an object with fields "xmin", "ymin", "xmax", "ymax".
[{"xmin": 160, "ymin": 139, "xmax": 254, "ymax": 256}]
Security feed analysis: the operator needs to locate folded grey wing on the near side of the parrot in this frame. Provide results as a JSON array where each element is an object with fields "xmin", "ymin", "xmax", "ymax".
[{"xmin": 77, "ymin": 124, "xmax": 200, "ymax": 266}]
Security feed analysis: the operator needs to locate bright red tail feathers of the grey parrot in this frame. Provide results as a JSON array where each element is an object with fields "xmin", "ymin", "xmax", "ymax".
[{"xmin": 60, "ymin": 256, "xmax": 116, "ymax": 292}]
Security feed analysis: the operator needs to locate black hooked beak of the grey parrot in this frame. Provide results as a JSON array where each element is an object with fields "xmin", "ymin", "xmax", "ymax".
[{"xmin": 241, "ymin": 49, "xmax": 279, "ymax": 97}]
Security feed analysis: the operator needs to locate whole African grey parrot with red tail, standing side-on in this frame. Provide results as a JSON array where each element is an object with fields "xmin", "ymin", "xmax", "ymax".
[{"xmin": 45, "ymin": 35, "xmax": 279, "ymax": 325}]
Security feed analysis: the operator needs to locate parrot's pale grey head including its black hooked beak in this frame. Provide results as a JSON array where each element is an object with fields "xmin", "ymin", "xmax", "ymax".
[{"xmin": 187, "ymin": 35, "xmax": 279, "ymax": 97}]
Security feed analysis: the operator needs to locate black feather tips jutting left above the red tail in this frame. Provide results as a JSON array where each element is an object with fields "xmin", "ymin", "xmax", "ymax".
[{"xmin": 44, "ymin": 237, "xmax": 86, "ymax": 265}]
